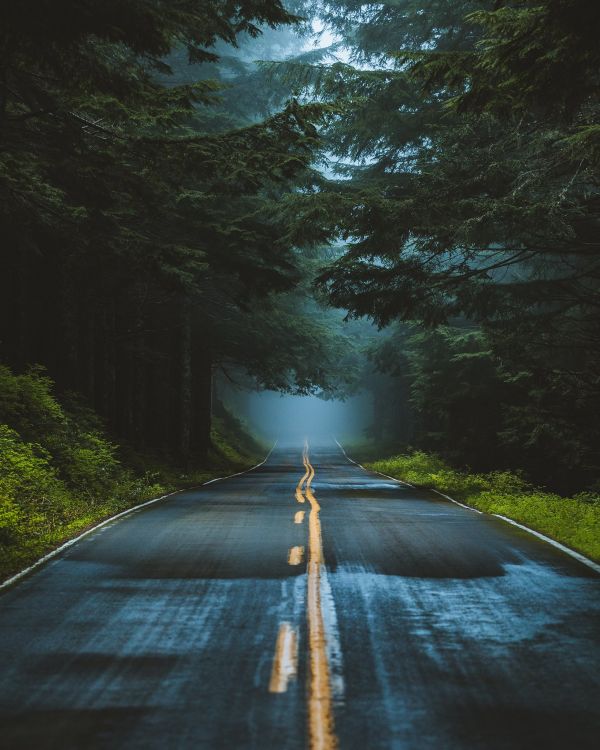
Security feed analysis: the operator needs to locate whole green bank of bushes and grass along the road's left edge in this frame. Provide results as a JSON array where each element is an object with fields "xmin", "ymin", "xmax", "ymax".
[{"xmin": 0, "ymin": 366, "xmax": 266, "ymax": 580}]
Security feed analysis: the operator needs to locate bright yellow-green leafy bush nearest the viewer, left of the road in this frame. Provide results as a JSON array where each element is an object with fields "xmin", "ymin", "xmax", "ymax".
[{"xmin": 0, "ymin": 365, "xmax": 164, "ymax": 576}]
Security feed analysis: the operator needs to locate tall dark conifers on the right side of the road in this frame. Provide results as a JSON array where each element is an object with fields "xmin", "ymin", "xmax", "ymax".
[{"xmin": 304, "ymin": 0, "xmax": 600, "ymax": 490}]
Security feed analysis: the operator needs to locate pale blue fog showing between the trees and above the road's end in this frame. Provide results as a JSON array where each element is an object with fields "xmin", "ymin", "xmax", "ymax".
[{"xmin": 204, "ymin": 18, "xmax": 392, "ymax": 452}]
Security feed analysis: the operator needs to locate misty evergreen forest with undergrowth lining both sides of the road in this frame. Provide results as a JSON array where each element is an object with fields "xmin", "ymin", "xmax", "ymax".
[{"xmin": 0, "ymin": 0, "xmax": 600, "ymax": 570}]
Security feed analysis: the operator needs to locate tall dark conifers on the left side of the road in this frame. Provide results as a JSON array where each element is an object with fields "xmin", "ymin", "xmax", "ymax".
[{"xmin": 0, "ymin": 0, "xmax": 328, "ymax": 462}]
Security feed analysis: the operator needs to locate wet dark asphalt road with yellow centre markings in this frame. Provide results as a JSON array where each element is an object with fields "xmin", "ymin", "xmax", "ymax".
[{"xmin": 0, "ymin": 441, "xmax": 600, "ymax": 750}]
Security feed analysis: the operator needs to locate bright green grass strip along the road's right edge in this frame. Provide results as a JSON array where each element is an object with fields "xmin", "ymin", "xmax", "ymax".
[{"xmin": 361, "ymin": 451, "xmax": 600, "ymax": 562}]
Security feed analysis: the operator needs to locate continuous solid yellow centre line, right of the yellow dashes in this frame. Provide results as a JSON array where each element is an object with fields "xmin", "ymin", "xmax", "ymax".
[{"xmin": 305, "ymin": 444, "xmax": 338, "ymax": 750}]
